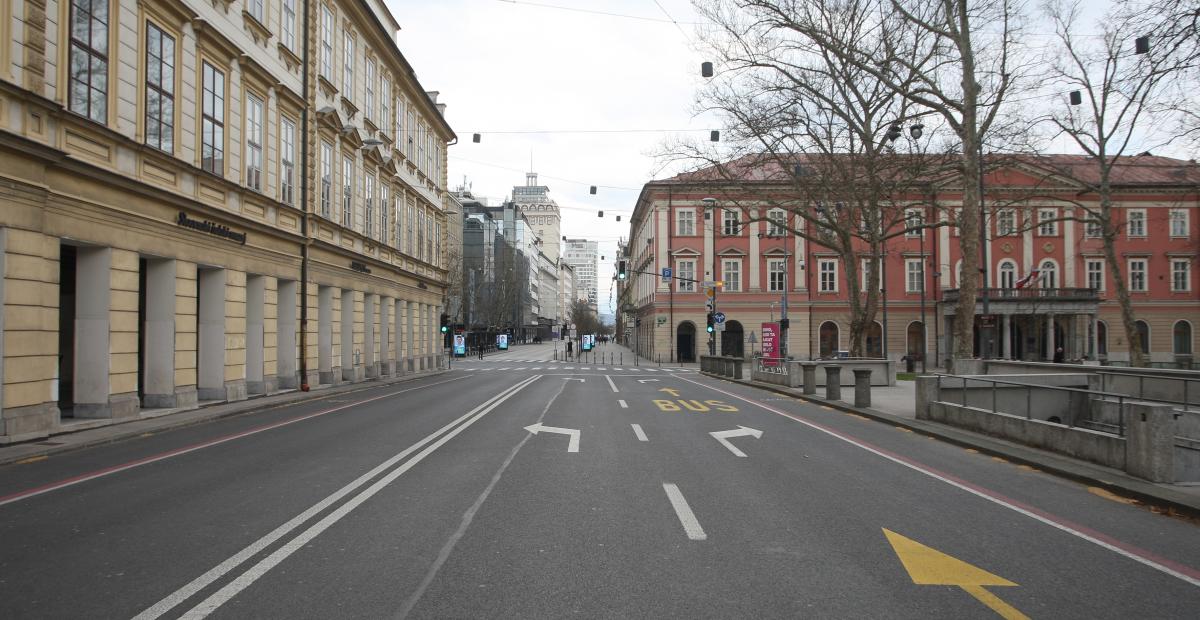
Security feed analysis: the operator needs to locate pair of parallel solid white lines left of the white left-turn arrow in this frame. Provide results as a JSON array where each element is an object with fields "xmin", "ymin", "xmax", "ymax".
[{"xmin": 133, "ymin": 375, "xmax": 540, "ymax": 620}]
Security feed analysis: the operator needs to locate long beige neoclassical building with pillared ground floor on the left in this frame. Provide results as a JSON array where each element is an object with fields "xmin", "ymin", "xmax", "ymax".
[{"xmin": 0, "ymin": 0, "xmax": 455, "ymax": 444}]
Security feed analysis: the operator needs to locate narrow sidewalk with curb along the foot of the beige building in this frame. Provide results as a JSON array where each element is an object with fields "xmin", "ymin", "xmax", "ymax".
[{"xmin": 0, "ymin": 369, "xmax": 450, "ymax": 466}]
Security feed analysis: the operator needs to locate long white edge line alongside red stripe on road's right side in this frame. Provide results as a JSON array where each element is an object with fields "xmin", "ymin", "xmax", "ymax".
[{"xmin": 683, "ymin": 379, "xmax": 1200, "ymax": 588}]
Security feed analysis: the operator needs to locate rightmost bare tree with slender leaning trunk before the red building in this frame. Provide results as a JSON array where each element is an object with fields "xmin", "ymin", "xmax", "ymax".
[{"xmin": 1043, "ymin": 0, "xmax": 1186, "ymax": 366}]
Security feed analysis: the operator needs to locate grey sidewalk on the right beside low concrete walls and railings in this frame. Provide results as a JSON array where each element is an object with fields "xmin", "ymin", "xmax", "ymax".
[{"xmin": 706, "ymin": 373, "xmax": 1200, "ymax": 517}]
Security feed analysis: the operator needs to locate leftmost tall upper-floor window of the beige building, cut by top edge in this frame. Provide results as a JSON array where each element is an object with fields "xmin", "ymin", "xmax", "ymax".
[{"xmin": 68, "ymin": 0, "xmax": 108, "ymax": 122}]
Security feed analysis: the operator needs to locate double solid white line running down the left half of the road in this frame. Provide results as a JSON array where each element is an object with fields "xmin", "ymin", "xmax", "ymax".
[{"xmin": 134, "ymin": 374, "xmax": 541, "ymax": 620}]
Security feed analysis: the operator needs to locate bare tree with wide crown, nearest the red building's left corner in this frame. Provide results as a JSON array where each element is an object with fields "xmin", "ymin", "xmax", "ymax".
[{"xmin": 686, "ymin": 0, "xmax": 942, "ymax": 356}]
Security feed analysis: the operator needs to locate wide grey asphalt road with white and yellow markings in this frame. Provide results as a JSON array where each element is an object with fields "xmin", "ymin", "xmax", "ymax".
[{"xmin": 0, "ymin": 347, "xmax": 1200, "ymax": 619}]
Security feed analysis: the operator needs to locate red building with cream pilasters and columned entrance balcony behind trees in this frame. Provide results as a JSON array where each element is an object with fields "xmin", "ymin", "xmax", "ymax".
[{"xmin": 618, "ymin": 155, "xmax": 1200, "ymax": 366}]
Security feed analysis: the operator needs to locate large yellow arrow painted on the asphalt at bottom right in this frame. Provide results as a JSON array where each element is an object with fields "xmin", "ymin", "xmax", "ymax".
[{"xmin": 883, "ymin": 528, "xmax": 1028, "ymax": 620}]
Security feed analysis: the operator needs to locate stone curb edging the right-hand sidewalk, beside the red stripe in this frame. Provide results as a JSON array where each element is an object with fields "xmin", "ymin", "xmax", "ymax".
[{"xmin": 701, "ymin": 373, "xmax": 1200, "ymax": 518}]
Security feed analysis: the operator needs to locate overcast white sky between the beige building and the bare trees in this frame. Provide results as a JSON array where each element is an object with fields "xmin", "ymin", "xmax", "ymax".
[{"xmin": 388, "ymin": 0, "xmax": 719, "ymax": 313}]
